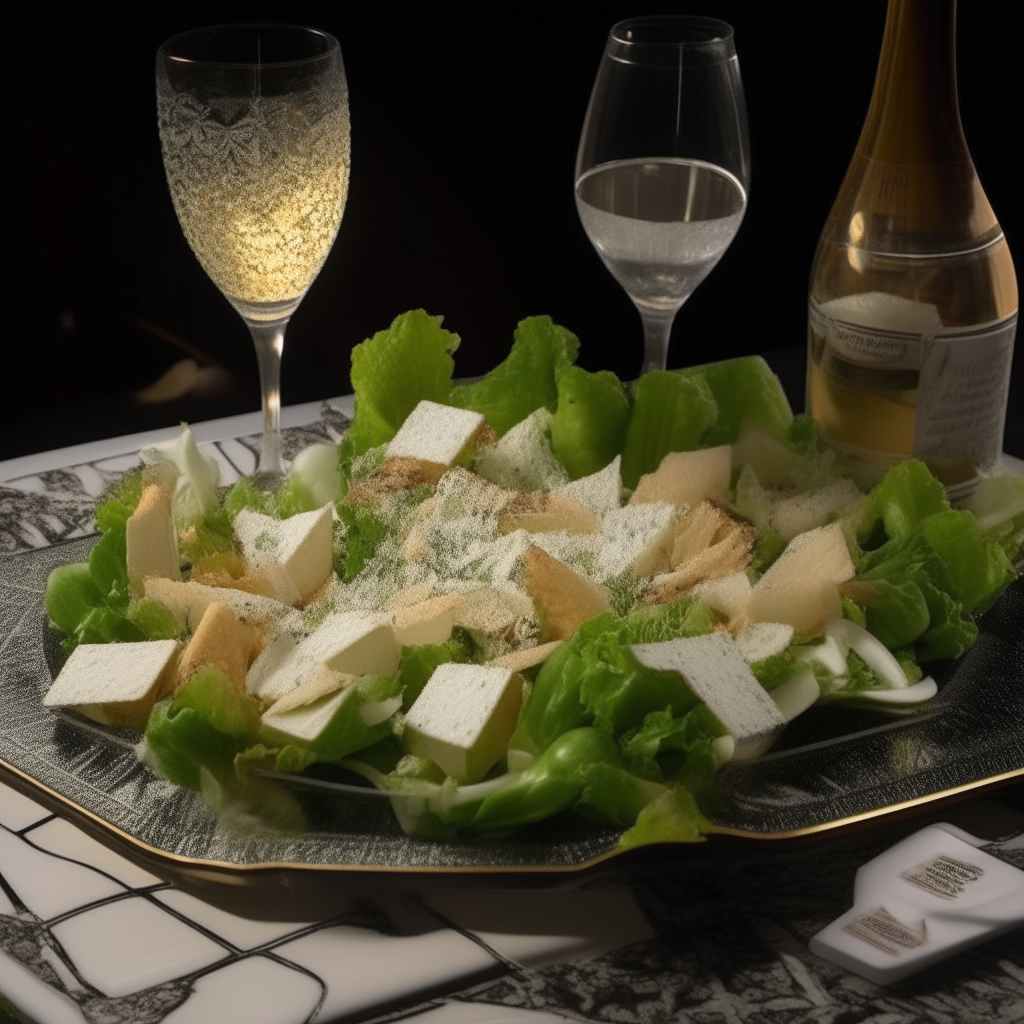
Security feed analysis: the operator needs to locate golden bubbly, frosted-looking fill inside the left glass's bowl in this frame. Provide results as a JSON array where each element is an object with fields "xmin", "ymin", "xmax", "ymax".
[{"xmin": 158, "ymin": 83, "xmax": 349, "ymax": 304}]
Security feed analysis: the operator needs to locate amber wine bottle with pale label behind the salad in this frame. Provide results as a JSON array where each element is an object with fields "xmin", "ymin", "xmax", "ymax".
[{"xmin": 807, "ymin": 0, "xmax": 1017, "ymax": 499}]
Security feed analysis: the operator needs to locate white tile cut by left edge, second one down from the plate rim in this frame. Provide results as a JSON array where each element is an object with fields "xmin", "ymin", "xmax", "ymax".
[{"xmin": 0, "ymin": 828, "xmax": 125, "ymax": 921}]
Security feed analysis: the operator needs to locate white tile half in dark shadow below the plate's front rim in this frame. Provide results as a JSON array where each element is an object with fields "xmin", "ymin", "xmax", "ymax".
[{"xmin": 424, "ymin": 887, "xmax": 655, "ymax": 968}]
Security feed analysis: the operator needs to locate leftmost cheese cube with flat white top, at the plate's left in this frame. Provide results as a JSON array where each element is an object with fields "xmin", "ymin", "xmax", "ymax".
[{"xmin": 43, "ymin": 640, "xmax": 178, "ymax": 729}]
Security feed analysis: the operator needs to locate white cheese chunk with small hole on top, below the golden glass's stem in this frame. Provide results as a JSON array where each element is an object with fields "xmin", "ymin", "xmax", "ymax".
[{"xmin": 233, "ymin": 503, "xmax": 334, "ymax": 601}]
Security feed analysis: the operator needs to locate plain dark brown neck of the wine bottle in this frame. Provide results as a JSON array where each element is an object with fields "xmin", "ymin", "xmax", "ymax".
[{"xmin": 857, "ymin": 0, "xmax": 971, "ymax": 166}]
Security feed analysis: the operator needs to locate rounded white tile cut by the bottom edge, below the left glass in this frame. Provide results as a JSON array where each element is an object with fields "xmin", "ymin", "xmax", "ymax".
[{"xmin": 162, "ymin": 956, "xmax": 323, "ymax": 1024}]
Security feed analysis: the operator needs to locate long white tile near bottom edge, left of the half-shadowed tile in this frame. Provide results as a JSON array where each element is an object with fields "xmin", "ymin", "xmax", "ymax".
[{"xmin": 274, "ymin": 925, "xmax": 495, "ymax": 1021}]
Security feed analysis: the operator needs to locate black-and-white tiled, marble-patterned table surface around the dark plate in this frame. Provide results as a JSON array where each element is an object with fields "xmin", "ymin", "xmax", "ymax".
[{"xmin": 0, "ymin": 399, "xmax": 1024, "ymax": 1024}]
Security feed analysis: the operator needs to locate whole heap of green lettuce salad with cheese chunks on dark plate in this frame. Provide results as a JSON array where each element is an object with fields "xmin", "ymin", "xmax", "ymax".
[{"xmin": 45, "ymin": 310, "xmax": 1024, "ymax": 847}]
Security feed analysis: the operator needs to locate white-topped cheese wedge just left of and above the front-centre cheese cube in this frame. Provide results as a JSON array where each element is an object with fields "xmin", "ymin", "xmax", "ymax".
[{"xmin": 250, "ymin": 612, "xmax": 401, "ymax": 700}]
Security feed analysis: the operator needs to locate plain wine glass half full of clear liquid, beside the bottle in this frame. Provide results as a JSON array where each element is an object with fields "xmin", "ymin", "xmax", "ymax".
[{"xmin": 575, "ymin": 15, "xmax": 751, "ymax": 373}]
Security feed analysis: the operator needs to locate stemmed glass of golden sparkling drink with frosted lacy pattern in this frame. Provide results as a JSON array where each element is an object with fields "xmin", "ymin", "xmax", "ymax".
[{"xmin": 157, "ymin": 25, "xmax": 349, "ymax": 489}]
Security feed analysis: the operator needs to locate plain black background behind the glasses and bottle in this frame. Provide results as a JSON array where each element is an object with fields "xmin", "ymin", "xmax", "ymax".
[{"xmin": 0, "ymin": 0, "xmax": 1024, "ymax": 459}]
